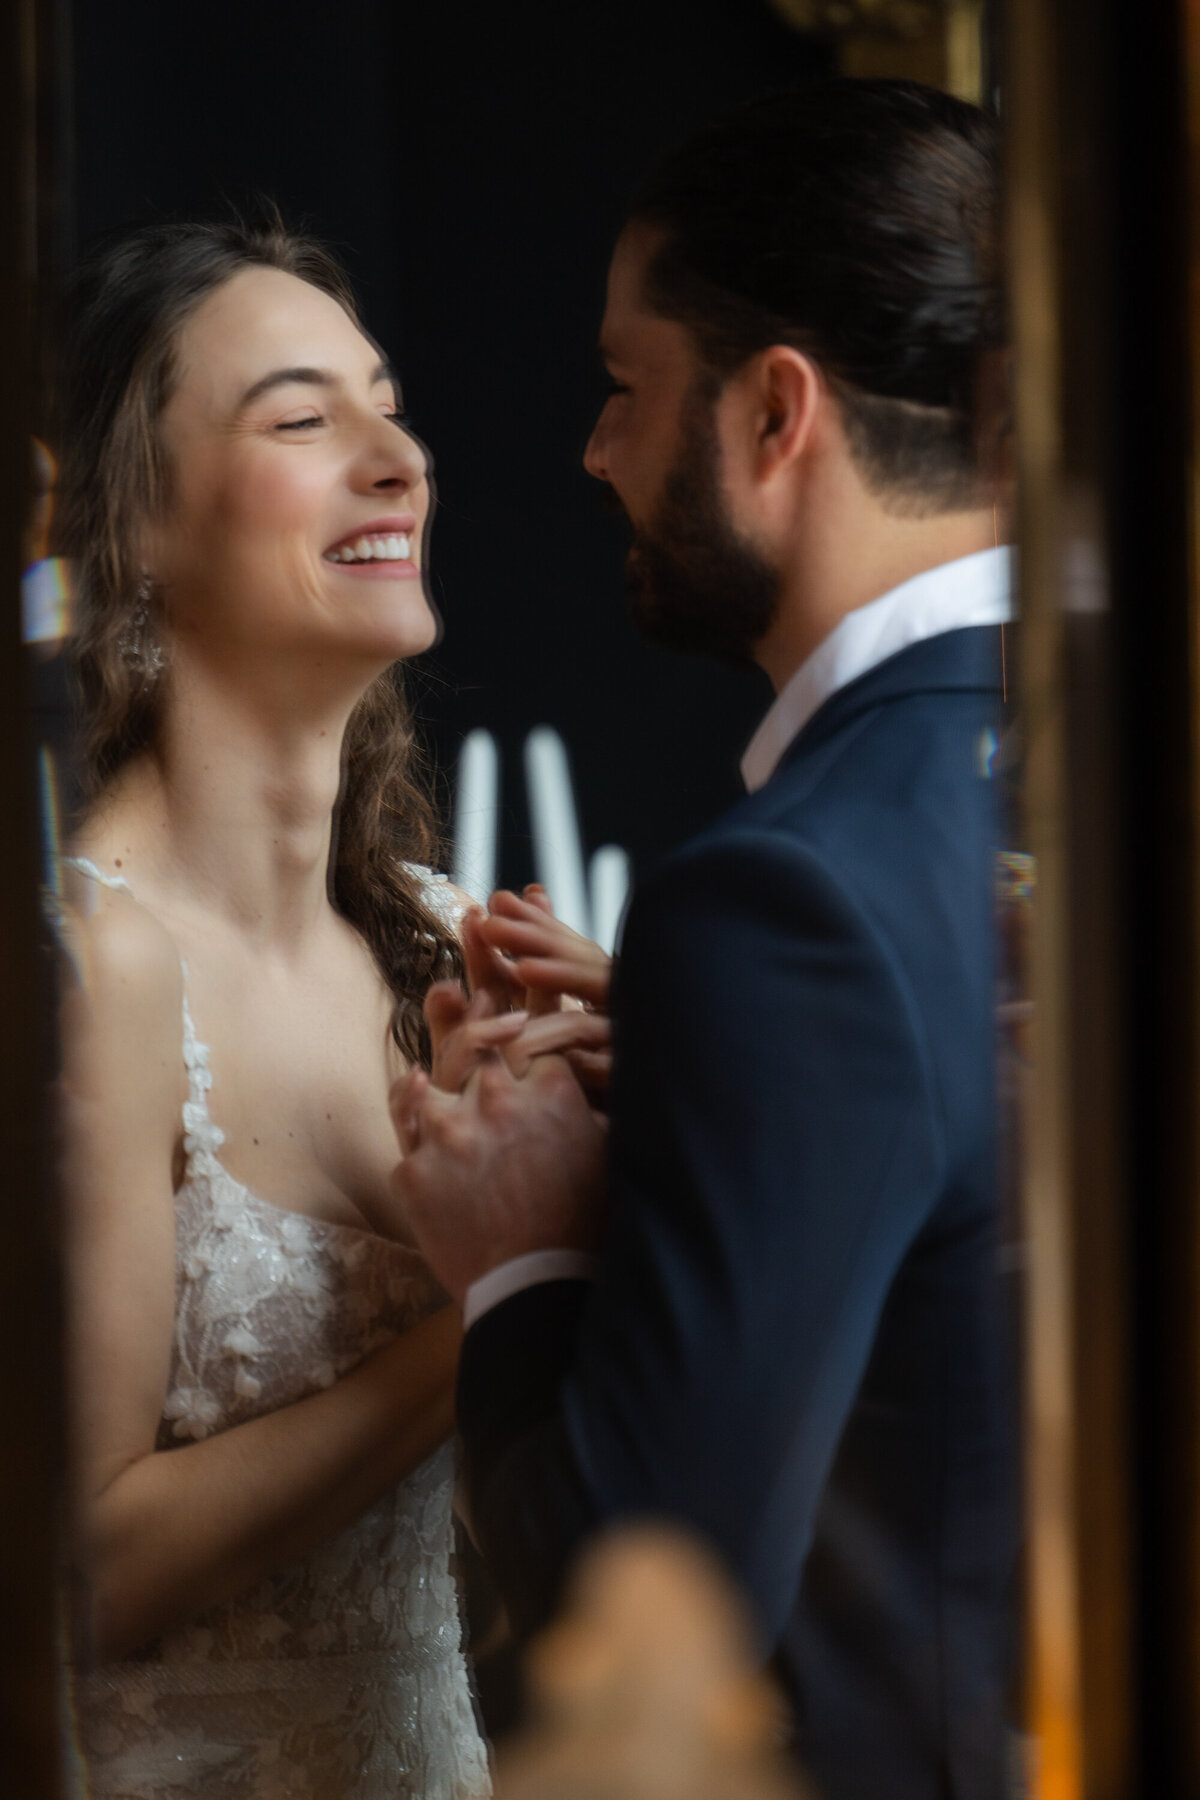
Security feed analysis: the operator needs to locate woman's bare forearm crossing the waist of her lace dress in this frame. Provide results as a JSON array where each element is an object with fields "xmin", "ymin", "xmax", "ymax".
[{"xmin": 81, "ymin": 1307, "xmax": 461, "ymax": 1660}]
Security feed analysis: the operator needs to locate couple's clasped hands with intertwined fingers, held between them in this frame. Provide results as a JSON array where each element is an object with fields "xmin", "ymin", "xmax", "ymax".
[{"xmin": 380, "ymin": 886, "xmax": 610, "ymax": 1301}]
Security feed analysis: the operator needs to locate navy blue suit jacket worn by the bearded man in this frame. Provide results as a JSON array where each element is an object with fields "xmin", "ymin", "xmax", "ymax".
[{"xmin": 459, "ymin": 628, "xmax": 1015, "ymax": 1800}]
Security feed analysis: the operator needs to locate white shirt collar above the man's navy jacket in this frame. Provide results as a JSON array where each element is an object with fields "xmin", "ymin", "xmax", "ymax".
[{"xmin": 741, "ymin": 544, "xmax": 1013, "ymax": 794}]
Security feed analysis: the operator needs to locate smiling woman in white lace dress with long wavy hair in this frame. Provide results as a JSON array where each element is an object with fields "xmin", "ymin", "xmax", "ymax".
[{"xmin": 51, "ymin": 223, "xmax": 604, "ymax": 1800}]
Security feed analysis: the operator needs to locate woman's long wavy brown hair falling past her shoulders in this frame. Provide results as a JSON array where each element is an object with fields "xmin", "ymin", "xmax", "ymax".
[{"xmin": 56, "ymin": 209, "xmax": 462, "ymax": 1067}]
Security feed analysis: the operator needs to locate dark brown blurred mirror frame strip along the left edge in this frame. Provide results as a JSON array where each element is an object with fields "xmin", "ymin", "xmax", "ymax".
[{"xmin": 0, "ymin": 0, "xmax": 63, "ymax": 1800}]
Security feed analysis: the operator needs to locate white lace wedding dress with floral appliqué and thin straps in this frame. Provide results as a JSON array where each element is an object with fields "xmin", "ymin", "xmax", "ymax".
[{"xmin": 63, "ymin": 860, "xmax": 489, "ymax": 1800}]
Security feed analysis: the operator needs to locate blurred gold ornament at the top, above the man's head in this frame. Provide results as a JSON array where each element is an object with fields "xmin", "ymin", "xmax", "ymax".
[{"xmin": 768, "ymin": 0, "xmax": 991, "ymax": 103}]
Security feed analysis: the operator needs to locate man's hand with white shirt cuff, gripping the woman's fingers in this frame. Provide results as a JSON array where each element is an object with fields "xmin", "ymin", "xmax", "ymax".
[{"xmin": 390, "ymin": 1051, "xmax": 606, "ymax": 1303}]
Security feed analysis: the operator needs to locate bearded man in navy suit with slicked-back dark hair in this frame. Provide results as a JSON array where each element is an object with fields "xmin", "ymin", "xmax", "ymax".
[{"xmin": 396, "ymin": 83, "xmax": 1015, "ymax": 1800}]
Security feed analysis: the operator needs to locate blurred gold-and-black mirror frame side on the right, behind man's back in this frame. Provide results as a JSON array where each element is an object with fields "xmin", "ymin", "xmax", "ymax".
[{"xmin": 1006, "ymin": 0, "xmax": 1200, "ymax": 1800}]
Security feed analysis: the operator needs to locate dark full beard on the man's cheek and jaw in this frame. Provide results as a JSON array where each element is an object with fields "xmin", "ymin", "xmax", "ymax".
[{"xmin": 624, "ymin": 387, "xmax": 781, "ymax": 662}]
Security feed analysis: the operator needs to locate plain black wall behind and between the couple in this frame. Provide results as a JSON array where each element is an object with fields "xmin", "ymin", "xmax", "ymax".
[{"xmin": 63, "ymin": 0, "xmax": 829, "ymax": 882}]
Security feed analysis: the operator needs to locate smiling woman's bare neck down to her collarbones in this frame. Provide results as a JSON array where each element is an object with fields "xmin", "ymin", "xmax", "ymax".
[{"xmin": 85, "ymin": 668, "xmax": 370, "ymax": 954}]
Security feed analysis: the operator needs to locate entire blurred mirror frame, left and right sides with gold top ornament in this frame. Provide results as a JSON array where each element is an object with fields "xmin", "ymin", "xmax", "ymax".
[{"xmin": 0, "ymin": 0, "xmax": 1200, "ymax": 1800}]
